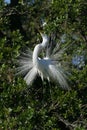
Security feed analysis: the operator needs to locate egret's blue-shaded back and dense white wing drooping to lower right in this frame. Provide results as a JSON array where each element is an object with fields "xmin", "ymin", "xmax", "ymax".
[{"xmin": 39, "ymin": 58, "xmax": 69, "ymax": 89}]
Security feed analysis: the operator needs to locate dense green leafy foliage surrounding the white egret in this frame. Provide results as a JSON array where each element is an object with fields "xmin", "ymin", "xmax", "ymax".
[{"xmin": 0, "ymin": 0, "xmax": 87, "ymax": 130}]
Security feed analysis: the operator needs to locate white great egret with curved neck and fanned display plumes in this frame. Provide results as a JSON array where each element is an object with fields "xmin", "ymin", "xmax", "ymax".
[{"xmin": 17, "ymin": 33, "xmax": 68, "ymax": 89}]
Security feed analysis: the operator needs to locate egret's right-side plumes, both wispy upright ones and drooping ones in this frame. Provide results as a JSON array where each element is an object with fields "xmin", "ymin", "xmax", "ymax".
[{"xmin": 46, "ymin": 39, "xmax": 69, "ymax": 89}]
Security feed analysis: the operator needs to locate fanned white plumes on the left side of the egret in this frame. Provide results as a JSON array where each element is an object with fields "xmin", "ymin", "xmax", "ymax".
[{"xmin": 16, "ymin": 49, "xmax": 37, "ymax": 85}]
